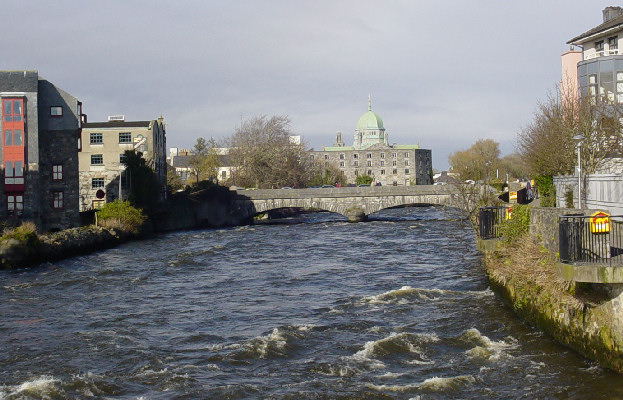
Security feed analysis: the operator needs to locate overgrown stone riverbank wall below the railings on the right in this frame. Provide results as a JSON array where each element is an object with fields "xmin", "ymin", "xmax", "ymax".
[{"xmin": 484, "ymin": 209, "xmax": 623, "ymax": 372}]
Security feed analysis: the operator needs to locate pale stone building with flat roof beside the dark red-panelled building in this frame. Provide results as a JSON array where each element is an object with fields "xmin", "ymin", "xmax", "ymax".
[{"xmin": 79, "ymin": 116, "xmax": 167, "ymax": 211}]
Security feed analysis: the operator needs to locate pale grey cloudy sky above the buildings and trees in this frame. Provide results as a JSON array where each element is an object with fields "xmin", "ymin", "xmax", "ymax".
[{"xmin": 0, "ymin": 0, "xmax": 621, "ymax": 170}]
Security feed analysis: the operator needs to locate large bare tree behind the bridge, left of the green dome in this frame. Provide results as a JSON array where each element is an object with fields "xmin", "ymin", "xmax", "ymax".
[{"xmin": 229, "ymin": 115, "xmax": 316, "ymax": 188}]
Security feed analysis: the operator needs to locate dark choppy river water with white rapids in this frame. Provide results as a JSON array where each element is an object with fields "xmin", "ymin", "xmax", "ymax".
[{"xmin": 0, "ymin": 207, "xmax": 623, "ymax": 399}]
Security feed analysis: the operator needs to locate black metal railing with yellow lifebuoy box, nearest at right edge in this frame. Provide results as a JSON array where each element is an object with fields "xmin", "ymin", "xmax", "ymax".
[{"xmin": 558, "ymin": 214, "xmax": 623, "ymax": 265}]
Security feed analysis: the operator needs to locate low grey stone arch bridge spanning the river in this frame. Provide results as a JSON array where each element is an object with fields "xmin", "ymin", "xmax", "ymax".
[{"xmin": 234, "ymin": 185, "xmax": 480, "ymax": 222}]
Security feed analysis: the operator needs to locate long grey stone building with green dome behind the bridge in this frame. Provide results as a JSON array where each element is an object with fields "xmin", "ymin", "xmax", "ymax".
[{"xmin": 311, "ymin": 98, "xmax": 433, "ymax": 186}]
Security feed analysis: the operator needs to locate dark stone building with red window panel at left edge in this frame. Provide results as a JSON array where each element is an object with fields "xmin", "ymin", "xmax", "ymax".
[{"xmin": 0, "ymin": 71, "xmax": 84, "ymax": 231}]
